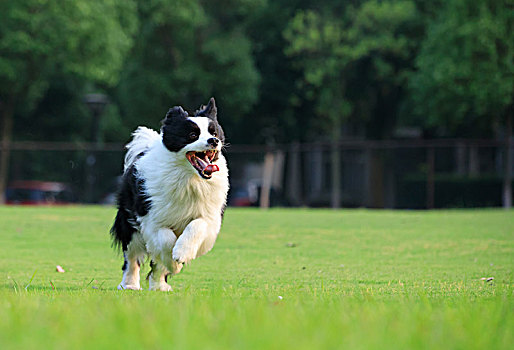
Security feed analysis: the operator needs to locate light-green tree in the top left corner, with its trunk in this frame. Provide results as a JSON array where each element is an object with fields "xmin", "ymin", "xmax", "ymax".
[{"xmin": 0, "ymin": 0, "xmax": 137, "ymax": 202}]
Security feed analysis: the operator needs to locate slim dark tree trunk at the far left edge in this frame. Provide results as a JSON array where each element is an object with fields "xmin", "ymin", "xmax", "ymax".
[{"xmin": 0, "ymin": 100, "xmax": 14, "ymax": 204}]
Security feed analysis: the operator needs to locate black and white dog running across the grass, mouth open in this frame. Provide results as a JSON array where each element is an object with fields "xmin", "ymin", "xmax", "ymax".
[{"xmin": 111, "ymin": 98, "xmax": 229, "ymax": 291}]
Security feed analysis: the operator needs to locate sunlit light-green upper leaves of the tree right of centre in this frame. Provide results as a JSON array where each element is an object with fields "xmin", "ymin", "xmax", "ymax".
[{"xmin": 284, "ymin": 0, "xmax": 415, "ymax": 87}]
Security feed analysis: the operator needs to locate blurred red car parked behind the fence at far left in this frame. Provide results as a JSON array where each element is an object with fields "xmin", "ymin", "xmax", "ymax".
[{"xmin": 5, "ymin": 181, "xmax": 74, "ymax": 205}]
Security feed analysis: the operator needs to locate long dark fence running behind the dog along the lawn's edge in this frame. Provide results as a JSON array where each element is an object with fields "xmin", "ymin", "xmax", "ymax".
[{"xmin": 2, "ymin": 140, "xmax": 512, "ymax": 209}]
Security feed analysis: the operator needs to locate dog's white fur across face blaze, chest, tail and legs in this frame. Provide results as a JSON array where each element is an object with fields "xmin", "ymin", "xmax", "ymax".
[{"xmin": 119, "ymin": 117, "xmax": 229, "ymax": 291}]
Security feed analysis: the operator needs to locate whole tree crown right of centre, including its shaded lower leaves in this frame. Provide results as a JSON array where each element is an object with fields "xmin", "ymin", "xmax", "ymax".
[{"xmin": 284, "ymin": 0, "xmax": 417, "ymax": 138}]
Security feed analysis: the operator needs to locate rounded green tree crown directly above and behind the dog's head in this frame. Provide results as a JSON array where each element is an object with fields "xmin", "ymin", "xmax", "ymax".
[{"xmin": 116, "ymin": 0, "xmax": 260, "ymax": 142}]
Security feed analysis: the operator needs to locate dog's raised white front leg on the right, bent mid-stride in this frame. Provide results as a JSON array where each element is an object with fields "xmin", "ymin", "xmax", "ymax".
[{"xmin": 173, "ymin": 219, "xmax": 220, "ymax": 264}]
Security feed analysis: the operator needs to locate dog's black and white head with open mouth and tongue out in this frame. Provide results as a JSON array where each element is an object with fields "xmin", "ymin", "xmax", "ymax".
[{"xmin": 162, "ymin": 98, "xmax": 225, "ymax": 179}]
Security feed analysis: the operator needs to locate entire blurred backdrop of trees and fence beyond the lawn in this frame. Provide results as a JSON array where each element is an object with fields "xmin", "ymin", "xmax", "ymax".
[{"xmin": 0, "ymin": 0, "xmax": 514, "ymax": 209}]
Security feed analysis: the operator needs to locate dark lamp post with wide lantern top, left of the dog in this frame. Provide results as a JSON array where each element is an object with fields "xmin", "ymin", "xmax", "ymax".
[{"xmin": 83, "ymin": 94, "xmax": 109, "ymax": 203}]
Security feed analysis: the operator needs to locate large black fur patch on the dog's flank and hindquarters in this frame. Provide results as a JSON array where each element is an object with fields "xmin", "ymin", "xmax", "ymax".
[{"xmin": 111, "ymin": 165, "xmax": 151, "ymax": 251}]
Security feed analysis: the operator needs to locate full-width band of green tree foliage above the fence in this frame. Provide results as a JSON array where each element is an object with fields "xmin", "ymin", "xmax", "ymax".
[{"xmin": 0, "ymin": 0, "xmax": 514, "ymax": 143}]
